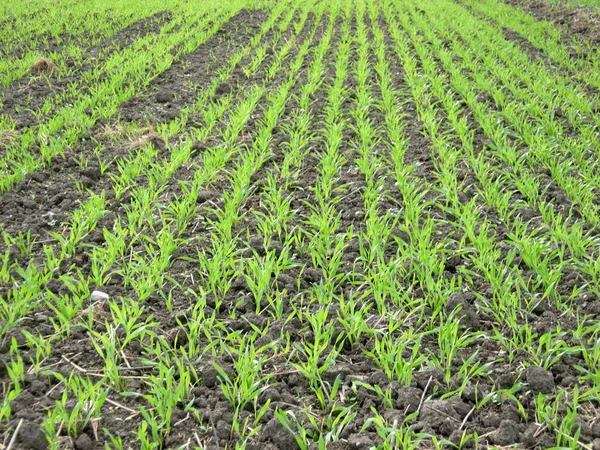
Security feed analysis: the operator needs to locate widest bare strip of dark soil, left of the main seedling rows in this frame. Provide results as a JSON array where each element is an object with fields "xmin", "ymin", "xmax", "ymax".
[{"xmin": 0, "ymin": 7, "xmax": 262, "ymax": 252}]
